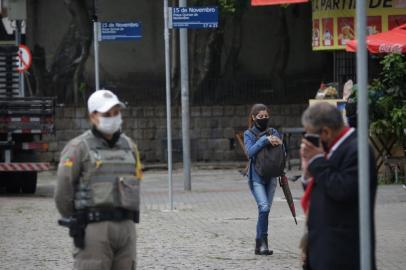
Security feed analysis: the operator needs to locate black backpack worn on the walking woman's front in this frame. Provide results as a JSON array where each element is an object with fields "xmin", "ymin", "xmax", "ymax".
[{"xmin": 250, "ymin": 128, "xmax": 286, "ymax": 181}]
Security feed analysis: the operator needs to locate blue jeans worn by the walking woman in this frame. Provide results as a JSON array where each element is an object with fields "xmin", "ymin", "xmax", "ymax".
[{"xmin": 249, "ymin": 178, "xmax": 277, "ymax": 239}]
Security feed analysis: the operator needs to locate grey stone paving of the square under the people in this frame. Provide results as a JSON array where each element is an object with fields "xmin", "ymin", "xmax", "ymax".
[{"xmin": 0, "ymin": 170, "xmax": 406, "ymax": 270}]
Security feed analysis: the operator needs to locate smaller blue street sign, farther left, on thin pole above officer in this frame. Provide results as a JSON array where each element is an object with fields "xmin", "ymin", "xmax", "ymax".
[{"xmin": 98, "ymin": 22, "xmax": 142, "ymax": 41}]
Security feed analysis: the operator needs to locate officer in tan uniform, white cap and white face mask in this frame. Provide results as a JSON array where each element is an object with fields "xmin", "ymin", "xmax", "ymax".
[{"xmin": 55, "ymin": 90, "xmax": 142, "ymax": 270}]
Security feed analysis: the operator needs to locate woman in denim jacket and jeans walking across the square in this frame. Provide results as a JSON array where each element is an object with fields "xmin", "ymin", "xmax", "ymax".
[{"xmin": 244, "ymin": 104, "xmax": 282, "ymax": 255}]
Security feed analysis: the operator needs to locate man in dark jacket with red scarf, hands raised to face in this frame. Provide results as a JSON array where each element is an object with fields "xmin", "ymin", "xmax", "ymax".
[{"xmin": 301, "ymin": 102, "xmax": 377, "ymax": 270}]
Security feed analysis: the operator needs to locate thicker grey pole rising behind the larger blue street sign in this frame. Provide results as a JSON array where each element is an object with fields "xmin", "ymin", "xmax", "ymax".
[{"xmin": 179, "ymin": 0, "xmax": 192, "ymax": 191}]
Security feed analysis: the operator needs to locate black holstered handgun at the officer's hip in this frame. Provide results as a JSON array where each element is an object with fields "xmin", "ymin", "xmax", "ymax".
[{"xmin": 58, "ymin": 211, "xmax": 87, "ymax": 249}]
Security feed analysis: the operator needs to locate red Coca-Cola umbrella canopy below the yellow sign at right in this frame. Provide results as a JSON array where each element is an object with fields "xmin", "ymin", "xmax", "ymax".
[{"xmin": 345, "ymin": 24, "xmax": 406, "ymax": 53}]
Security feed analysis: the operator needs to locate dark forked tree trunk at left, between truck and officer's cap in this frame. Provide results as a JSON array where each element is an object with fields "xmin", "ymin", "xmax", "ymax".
[{"xmin": 31, "ymin": 0, "xmax": 93, "ymax": 105}]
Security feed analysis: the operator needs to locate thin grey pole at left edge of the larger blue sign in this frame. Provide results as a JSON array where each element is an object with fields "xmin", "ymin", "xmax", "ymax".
[{"xmin": 164, "ymin": 0, "xmax": 173, "ymax": 210}]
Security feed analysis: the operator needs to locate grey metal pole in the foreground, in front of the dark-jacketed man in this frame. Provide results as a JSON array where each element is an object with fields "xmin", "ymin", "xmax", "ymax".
[{"xmin": 356, "ymin": 0, "xmax": 372, "ymax": 270}]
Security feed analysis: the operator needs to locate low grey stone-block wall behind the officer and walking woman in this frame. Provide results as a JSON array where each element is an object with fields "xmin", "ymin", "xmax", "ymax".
[{"xmin": 40, "ymin": 104, "xmax": 305, "ymax": 165}]
